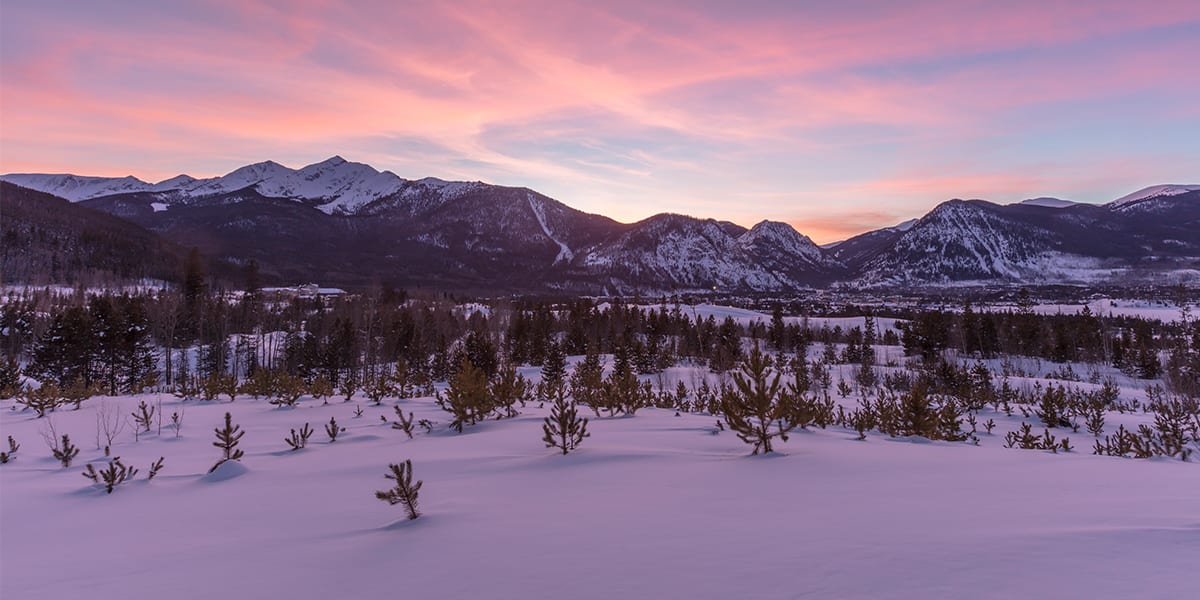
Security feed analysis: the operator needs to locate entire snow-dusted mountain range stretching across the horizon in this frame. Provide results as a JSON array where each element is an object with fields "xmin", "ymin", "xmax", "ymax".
[{"xmin": 0, "ymin": 156, "xmax": 1200, "ymax": 294}]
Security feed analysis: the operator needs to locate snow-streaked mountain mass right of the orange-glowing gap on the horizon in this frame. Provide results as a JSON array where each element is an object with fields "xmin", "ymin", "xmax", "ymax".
[{"xmin": 854, "ymin": 191, "xmax": 1200, "ymax": 286}]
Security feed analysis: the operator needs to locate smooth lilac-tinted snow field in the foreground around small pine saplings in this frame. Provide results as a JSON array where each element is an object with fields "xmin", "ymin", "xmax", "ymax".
[{"xmin": 0, "ymin": 370, "xmax": 1200, "ymax": 600}]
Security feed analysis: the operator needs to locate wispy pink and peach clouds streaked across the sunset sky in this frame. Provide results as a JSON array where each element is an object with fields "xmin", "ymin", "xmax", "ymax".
[{"xmin": 0, "ymin": 1, "xmax": 1200, "ymax": 230}]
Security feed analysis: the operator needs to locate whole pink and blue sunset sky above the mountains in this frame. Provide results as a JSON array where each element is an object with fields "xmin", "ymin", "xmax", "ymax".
[{"xmin": 0, "ymin": 0, "xmax": 1200, "ymax": 242}]
